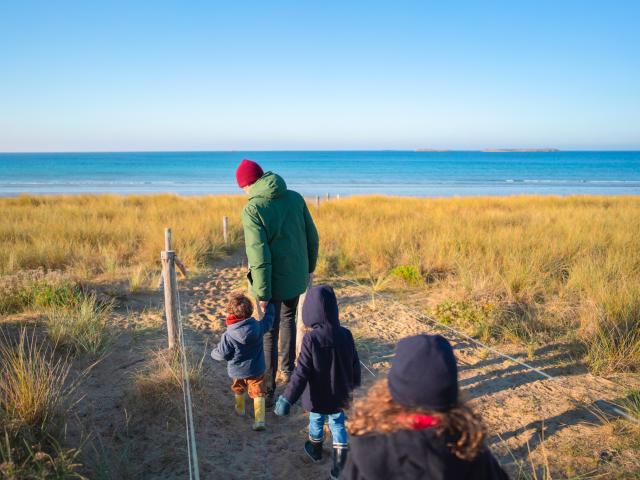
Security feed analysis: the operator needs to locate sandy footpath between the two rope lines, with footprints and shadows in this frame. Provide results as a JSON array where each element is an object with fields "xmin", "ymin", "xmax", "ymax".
[{"xmin": 179, "ymin": 258, "xmax": 637, "ymax": 478}]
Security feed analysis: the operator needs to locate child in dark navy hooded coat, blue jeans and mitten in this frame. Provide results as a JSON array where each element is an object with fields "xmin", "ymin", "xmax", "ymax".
[{"xmin": 274, "ymin": 285, "xmax": 361, "ymax": 478}]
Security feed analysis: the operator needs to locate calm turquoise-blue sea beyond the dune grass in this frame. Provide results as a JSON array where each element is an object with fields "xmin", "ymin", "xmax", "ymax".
[{"xmin": 0, "ymin": 151, "xmax": 640, "ymax": 197}]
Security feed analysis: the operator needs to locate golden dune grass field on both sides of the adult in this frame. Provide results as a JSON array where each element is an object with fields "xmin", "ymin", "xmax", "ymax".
[{"xmin": 0, "ymin": 195, "xmax": 640, "ymax": 373}]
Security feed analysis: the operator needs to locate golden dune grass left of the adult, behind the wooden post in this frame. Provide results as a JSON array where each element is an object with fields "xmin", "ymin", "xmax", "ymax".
[{"xmin": 0, "ymin": 195, "xmax": 242, "ymax": 278}]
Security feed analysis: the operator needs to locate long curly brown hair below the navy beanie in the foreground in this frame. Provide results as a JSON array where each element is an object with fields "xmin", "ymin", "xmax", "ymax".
[{"xmin": 348, "ymin": 379, "xmax": 486, "ymax": 460}]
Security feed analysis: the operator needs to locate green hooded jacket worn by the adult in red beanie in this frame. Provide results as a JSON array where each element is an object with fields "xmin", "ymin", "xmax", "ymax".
[{"xmin": 242, "ymin": 172, "xmax": 319, "ymax": 300}]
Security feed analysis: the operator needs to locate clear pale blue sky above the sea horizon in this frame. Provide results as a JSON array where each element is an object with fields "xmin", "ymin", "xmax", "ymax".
[{"xmin": 0, "ymin": 0, "xmax": 640, "ymax": 151}]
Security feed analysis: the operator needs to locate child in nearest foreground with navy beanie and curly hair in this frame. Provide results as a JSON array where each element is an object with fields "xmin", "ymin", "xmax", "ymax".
[{"xmin": 340, "ymin": 335, "xmax": 508, "ymax": 480}]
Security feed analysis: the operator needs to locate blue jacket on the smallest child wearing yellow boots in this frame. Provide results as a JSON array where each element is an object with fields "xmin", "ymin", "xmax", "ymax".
[{"xmin": 211, "ymin": 303, "xmax": 276, "ymax": 378}]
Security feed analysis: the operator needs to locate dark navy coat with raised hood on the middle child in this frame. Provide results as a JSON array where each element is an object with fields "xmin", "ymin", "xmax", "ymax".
[{"xmin": 284, "ymin": 285, "xmax": 360, "ymax": 414}]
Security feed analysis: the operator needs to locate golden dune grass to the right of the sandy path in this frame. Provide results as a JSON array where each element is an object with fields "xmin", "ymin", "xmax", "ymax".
[{"xmin": 315, "ymin": 196, "xmax": 640, "ymax": 373}]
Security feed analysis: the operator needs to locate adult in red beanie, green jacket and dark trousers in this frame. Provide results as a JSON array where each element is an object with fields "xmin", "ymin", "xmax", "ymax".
[{"xmin": 236, "ymin": 159, "xmax": 319, "ymax": 404}]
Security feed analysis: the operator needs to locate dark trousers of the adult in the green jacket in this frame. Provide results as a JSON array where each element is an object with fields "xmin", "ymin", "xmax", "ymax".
[{"xmin": 263, "ymin": 296, "xmax": 300, "ymax": 395}]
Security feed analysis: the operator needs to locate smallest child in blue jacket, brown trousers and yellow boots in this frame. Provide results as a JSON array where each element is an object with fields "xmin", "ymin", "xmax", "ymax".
[{"xmin": 211, "ymin": 293, "xmax": 275, "ymax": 430}]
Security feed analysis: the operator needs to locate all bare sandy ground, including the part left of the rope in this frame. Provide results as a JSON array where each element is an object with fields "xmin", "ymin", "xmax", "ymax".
[{"xmin": 70, "ymin": 256, "xmax": 640, "ymax": 480}]
